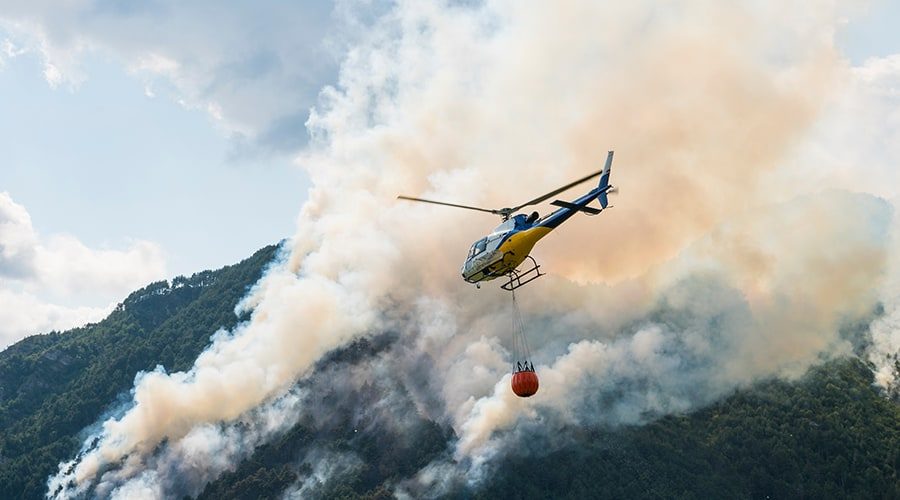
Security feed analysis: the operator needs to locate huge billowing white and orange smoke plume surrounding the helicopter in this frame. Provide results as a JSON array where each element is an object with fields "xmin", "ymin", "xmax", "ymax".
[{"xmin": 49, "ymin": 0, "xmax": 896, "ymax": 498}]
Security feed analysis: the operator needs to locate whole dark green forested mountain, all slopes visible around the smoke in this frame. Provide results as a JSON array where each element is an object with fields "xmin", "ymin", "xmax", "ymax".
[{"xmin": 0, "ymin": 247, "xmax": 900, "ymax": 499}]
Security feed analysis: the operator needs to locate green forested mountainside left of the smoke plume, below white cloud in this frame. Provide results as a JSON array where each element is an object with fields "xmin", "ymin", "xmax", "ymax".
[{"xmin": 0, "ymin": 246, "xmax": 276, "ymax": 499}]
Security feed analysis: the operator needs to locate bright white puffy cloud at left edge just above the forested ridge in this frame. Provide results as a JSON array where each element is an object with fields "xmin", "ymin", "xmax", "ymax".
[{"xmin": 0, "ymin": 192, "xmax": 166, "ymax": 348}]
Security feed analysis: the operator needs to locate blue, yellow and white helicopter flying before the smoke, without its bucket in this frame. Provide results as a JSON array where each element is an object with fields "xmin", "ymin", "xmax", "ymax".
[{"xmin": 397, "ymin": 151, "xmax": 617, "ymax": 291}]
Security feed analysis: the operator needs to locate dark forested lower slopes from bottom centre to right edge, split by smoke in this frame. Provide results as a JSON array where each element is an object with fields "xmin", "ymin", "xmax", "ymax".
[{"xmin": 192, "ymin": 359, "xmax": 900, "ymax": 499}]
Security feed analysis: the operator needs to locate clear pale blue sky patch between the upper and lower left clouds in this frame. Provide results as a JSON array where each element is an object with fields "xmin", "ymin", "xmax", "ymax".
[{"xmin": 0, "ymin": 51, "xmax": 307, "ymax": 274}]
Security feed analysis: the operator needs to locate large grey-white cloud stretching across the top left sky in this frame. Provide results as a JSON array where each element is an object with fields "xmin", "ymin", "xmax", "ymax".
[{"xmin": 0, "ymin": 0, "xmax": 338, "ymax": 152}]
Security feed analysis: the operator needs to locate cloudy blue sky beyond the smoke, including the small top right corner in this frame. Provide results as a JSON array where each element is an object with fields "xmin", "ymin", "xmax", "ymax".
[{"xmin": 0, "ymin": 0, "xmax": 900, "ymax": 347}]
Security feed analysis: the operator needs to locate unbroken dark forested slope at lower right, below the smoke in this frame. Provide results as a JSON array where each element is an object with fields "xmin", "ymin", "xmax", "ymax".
[{"xmin": 477, "ymin": 359, "xmax": 900, "ymax": 499}]
